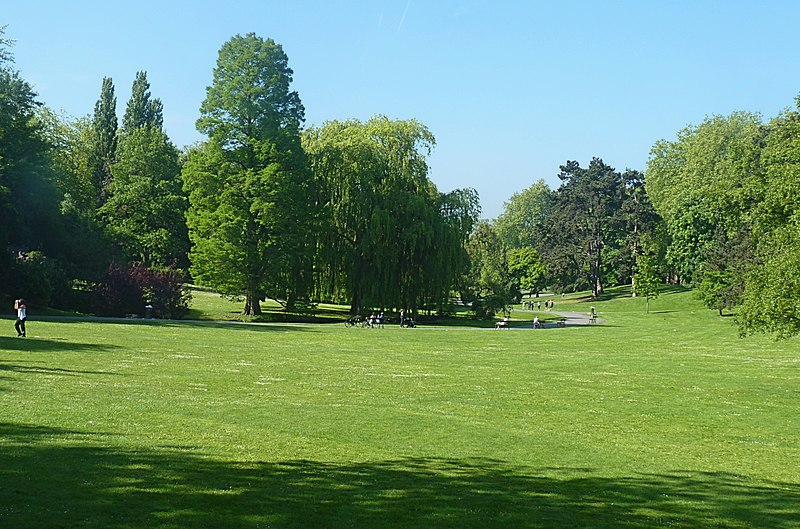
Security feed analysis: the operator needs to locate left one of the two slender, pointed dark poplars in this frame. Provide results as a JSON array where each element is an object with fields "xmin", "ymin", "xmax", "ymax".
[{"xmin": 91, "ymin": 77, "xmax": 117, "ymax": 205}]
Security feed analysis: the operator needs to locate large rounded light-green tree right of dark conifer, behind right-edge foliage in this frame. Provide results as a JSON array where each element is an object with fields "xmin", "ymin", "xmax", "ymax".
[{"xmin": 645, "ymin": 112, "xmax": 763, "ymax": 283}]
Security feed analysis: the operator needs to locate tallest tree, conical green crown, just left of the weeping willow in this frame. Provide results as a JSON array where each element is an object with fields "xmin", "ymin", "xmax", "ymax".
[{"xmin": 183, "ymin": 33, "xmax": 316, "ymax": 315}]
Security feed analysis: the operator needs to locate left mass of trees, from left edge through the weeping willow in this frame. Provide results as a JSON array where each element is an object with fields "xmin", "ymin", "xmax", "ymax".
[{"xmin": 0, "ymin": 33, "xmax": 480, "ymax": 317}]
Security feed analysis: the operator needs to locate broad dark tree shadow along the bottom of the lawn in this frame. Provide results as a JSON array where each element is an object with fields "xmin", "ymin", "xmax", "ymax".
[{"xmin": 0, "ymin": 424, "xmax": 800, "ymax": 529}]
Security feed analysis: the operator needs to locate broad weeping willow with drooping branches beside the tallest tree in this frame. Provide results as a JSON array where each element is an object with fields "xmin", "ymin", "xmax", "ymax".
[{"xmin": 303, "ymin": 117, "xmax": 479, "ymax": 314}]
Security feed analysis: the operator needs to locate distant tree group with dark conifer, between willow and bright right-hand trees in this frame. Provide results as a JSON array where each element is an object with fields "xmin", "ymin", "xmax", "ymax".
[{"xmin": 463, "ymin": 158, "xmax": 660, "ymax": 313}]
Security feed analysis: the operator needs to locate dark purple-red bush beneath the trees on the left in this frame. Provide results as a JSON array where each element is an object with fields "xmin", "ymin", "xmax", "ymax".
[{"xmin": 94, "ymin": 263, "xmax": 191, "ymax": 319}]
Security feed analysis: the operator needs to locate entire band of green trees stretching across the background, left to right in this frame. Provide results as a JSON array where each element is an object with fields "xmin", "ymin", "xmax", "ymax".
[{"xmin": 0, "ymin": 25, "xmax": 800, "ymax": 337}]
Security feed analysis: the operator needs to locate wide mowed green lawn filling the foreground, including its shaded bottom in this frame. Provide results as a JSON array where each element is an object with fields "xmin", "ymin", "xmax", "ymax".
[{"xmin": 0, "ymin": 293, "xmax": 800, "ymax": 529}]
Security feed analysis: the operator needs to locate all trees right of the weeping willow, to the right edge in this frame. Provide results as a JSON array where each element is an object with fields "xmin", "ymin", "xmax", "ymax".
[{"xmin": 484, "ymin": 101, "xmax": 800, "ymax": 337}]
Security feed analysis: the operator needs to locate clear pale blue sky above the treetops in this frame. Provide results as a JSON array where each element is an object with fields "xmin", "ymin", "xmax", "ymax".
[{"xmin": 0, "ymin": 0, "xmax": 800, "ymax": 218}]
